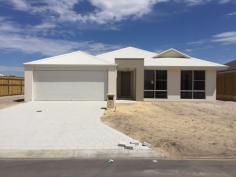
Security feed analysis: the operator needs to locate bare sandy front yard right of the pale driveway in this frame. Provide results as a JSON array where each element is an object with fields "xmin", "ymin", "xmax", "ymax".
[{"xmin": 102, "ymin": 101, "xmax": 236, "ymax": 159}]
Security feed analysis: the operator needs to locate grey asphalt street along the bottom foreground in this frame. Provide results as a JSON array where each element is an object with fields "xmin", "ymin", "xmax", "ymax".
[{"xmin": 0, "ymin": 159, "xmax": 236, "ymax": 177}]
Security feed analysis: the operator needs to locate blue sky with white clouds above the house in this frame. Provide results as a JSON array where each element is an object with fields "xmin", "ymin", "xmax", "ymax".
[{"xmin": 0, "ymin": 0, "xmax": 236, "ymax": 75}]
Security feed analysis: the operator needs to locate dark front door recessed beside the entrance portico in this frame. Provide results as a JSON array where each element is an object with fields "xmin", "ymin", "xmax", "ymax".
[{"xmin": 117, "ymin": 71, "xmax": 131, "ymax": 98}]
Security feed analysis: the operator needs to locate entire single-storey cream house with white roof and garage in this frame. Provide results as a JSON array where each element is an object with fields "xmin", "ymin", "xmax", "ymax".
[{"xmin": 24, "ymin": 47, "xmax": 226, "ymax": 101}]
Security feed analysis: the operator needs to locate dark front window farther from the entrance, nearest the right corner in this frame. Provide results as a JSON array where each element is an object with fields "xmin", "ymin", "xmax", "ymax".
[{"xmin": 181, "ymin": 70, "xmax": 206, "ymax": 99}]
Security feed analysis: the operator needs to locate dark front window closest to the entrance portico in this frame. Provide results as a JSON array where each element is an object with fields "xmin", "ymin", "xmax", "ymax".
[{"xmin": 144, "ymin": 70, "xmax": 167, "ymax": 98}]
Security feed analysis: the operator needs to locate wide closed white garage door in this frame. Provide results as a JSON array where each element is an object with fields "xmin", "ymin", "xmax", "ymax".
[{"xmin": 33, "ymin": 71, "xmax": 107, "ymax": 101}]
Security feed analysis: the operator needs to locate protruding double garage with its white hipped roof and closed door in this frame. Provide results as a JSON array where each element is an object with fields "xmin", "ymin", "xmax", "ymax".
[{"xmin": 24, "ymin": 51, "xmax": 116, "ymax": 101}]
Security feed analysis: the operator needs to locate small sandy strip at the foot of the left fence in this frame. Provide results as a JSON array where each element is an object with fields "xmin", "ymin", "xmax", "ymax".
[{"xmin": 0, "ymin": 95, "xmax": 24, "ymax": 109}]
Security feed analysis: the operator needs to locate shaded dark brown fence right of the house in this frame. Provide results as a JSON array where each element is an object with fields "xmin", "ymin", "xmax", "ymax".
[{"xmin": 217, "ymin": 71, "xmax": 236, "ymax": 101}]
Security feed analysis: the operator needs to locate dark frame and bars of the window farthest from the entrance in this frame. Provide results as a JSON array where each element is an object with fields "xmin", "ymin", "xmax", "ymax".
[{"xmin": 180, "ymin": 70, "xmax": 206, "ymax": 100}]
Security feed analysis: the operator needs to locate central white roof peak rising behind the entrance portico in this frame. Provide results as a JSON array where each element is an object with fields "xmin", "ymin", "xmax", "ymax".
[{"xmin": 97, "ymin": 47, "xmax": 157, "ymax": 64}]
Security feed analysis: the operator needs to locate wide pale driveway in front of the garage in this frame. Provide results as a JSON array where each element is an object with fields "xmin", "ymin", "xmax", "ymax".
[{"xmin": 0, "ymin": 101, "xmax": 155, "ymax": 157}]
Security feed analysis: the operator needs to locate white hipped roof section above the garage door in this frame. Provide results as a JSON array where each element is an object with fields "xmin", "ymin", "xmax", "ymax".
[{"xmin": 24, "ymin": 51, "xmax": 114, "ymax": 65}]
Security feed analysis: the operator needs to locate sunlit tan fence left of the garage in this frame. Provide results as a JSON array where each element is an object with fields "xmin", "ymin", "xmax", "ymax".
[{"xmin": 0, "ymin": 77, "xmax": 24, "ymax": 96}]
